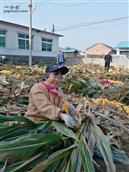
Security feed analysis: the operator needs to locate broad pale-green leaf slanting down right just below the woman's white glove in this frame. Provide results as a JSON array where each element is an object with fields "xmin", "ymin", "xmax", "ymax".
[{"xmin": 52, "ymin": 122, "xmax": 79, "ymax": 141}]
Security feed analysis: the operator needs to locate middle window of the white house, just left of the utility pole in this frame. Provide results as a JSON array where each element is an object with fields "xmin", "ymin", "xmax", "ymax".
[{"xmin": 18, "ymin": 33, "xmax": 33, "ymax": 49}]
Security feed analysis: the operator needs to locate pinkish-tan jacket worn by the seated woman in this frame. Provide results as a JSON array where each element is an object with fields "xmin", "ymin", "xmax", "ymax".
[{"xmin": 25, "ymin": 83, "xmax": 66, "ymax": 121}]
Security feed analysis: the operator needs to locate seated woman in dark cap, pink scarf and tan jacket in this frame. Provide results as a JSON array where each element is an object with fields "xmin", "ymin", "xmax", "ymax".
[{"xmin": 25, "ymin": 64, "xmax": 77, "ymax": 128}]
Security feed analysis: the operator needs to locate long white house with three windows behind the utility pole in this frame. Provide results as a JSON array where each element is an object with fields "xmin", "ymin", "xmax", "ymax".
[{"xmin": 0, "ymin": 20, "xmax": 62, "ymax": 63}]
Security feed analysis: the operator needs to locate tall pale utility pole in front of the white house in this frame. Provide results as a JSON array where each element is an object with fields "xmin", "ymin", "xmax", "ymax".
[{"xmin": 28, "ymin": 0, "xmax": 32, "ymax": 66}]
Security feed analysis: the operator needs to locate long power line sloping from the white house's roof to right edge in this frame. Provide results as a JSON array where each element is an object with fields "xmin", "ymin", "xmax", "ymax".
[{"xmin": 55, "ymin": 16, "xmax": 129, "ymax": 31}]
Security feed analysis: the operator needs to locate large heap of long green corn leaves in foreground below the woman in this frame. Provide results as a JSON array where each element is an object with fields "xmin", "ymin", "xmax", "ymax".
[{"xmin": 0, "ymin": 115, "xmax": 129, "ymax": 172}]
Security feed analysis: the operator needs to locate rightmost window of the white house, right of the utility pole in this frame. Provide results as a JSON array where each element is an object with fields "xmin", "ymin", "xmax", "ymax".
[{"xmin": 42, "ymin": 38, "xmax": 52, "ymax": 51}]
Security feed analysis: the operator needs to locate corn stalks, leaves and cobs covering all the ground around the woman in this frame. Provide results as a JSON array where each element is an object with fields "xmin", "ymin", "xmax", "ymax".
[{"xmin": 0, "ymin": 64, "xmax": 129, "ymax": 172}]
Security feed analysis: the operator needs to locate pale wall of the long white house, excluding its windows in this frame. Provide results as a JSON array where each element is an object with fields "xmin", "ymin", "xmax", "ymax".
[{"xmin": 0, "ymin": 23, "xmax": 59, "ymax": 57}]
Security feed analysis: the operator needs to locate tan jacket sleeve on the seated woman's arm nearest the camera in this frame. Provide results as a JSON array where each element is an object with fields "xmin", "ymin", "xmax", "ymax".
[{"xmin": 30, "ymin": 86, "xmax": 61, "ymax": 120}]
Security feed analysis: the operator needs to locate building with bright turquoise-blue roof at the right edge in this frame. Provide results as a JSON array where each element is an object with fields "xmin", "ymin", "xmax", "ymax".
[{"xmin": 116, "ymin": 41, "xmax": 129, "ymax": 56}]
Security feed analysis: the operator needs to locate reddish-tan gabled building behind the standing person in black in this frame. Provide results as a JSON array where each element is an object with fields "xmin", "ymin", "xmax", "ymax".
[{"xmin": 85, "ymin": 43, "xmax": 116, "ymax": 57}]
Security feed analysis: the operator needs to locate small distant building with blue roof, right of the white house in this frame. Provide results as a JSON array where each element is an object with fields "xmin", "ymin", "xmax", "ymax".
[{"xmin": 61, "ymin": 49, "xmax": 80, "ymax": 57}]
